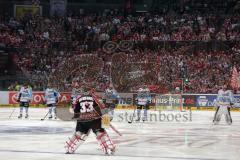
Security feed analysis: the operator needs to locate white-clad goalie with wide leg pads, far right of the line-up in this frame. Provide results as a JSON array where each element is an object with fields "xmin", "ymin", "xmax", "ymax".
[{"xmin": 213, "ymin": 85, "xmax": 234, "ymax": 125}]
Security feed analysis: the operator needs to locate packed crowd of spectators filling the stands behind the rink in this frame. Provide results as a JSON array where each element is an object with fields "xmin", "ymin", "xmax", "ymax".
[{"xmin": 0, "ymin": 5, "xmax": 240, "ymax": 93}]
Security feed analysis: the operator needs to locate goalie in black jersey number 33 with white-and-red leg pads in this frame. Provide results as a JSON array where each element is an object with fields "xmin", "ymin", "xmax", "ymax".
[{"xmin": 65, "ymin": 86, "xmax": 115, "ymax": 155}]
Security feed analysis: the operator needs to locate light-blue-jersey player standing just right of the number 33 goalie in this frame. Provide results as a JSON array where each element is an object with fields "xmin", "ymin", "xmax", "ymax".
[{"xmin": 104, "ymin": 84, "xmax": 119, "ymax": 121}]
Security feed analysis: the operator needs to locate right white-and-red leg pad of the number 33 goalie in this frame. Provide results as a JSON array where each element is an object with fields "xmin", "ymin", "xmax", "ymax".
[{"xmin": 96, "ymin": 131, "xmax": 115, "ymax": 155}]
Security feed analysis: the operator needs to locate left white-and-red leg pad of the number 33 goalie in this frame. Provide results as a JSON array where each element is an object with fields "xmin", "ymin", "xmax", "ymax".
[{"xmin": 65, "ymin": 131, "xmax": 89, "ymax": 154}]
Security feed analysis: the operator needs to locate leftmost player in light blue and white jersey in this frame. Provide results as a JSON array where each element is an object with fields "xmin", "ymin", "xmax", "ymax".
[{"xmin": 17, "ymin": 83, "xmax": 32, "ymax": 119}]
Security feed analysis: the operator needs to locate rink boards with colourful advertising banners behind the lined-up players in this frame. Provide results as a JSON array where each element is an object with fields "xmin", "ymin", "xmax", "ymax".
[{"xmin": 0, "ymin": 91, "xmax": 240, "ymax": 111}]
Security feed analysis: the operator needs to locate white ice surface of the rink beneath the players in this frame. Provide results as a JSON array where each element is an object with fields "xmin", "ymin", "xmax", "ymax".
[{"xmin": 0, "ymin": 108, "xmax": 240, "ymax": 160}]
